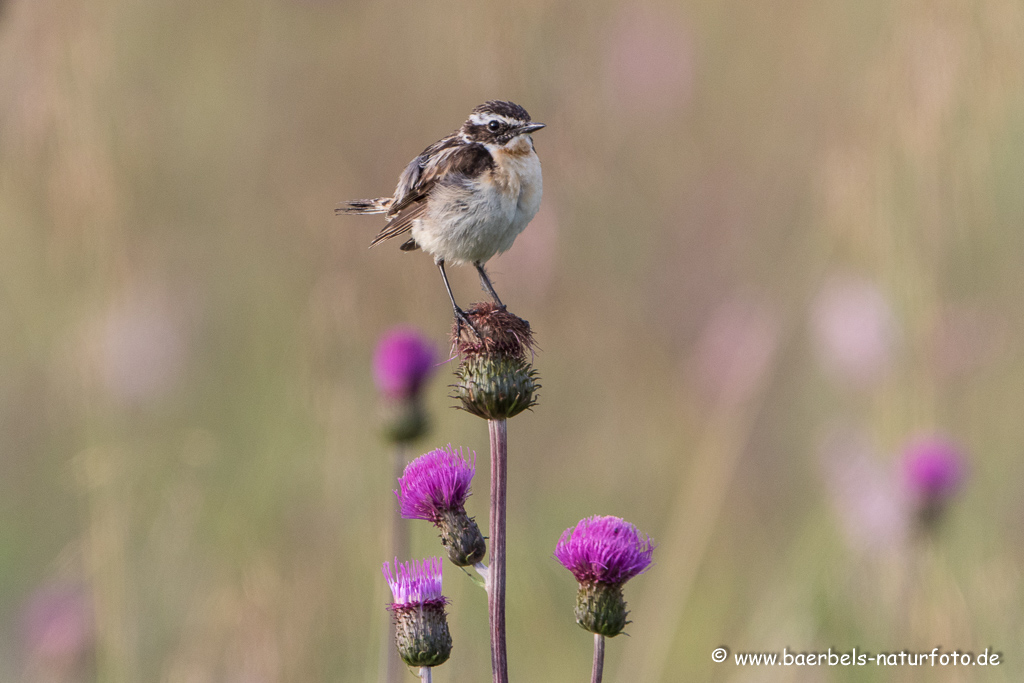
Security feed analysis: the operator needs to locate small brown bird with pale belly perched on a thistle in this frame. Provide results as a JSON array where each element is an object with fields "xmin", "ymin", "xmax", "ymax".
[{"xmin": 336, "ymin": 100, "xmax": 544, "ymax": 328}]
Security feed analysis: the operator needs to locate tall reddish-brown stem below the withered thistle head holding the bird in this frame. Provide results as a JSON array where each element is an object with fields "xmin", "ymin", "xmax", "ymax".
[{"xmin": 487, "ymin": 420, "xmax": 509, "ymax": 683}]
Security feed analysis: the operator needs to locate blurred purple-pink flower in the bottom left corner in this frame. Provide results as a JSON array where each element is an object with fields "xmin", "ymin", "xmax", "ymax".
[{"xmin": 22, "ymin": 584, "xmax": 94, "ymax": 669}]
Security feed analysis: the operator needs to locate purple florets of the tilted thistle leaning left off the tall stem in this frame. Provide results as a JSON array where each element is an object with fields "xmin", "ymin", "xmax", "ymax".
[{"xmin": 394, "ymin": 443, "xmax": 476, "ymax": 523}]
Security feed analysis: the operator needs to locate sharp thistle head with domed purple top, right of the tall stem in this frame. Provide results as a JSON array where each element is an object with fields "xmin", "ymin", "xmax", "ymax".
[{"xmin": 555, "ymin": 516, "xmax": 654, "ymax": 638}]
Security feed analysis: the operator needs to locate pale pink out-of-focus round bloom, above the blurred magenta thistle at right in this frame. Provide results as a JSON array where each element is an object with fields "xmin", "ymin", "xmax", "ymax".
[{"xmin": 811, "ymin": 275, "xmax": 896, "ymax": 386}]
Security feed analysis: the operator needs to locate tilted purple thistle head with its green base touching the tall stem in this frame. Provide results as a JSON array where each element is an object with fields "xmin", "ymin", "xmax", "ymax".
[{"xmin": 394, "ymin": 444, "xmax": 487, "ymax": 566}]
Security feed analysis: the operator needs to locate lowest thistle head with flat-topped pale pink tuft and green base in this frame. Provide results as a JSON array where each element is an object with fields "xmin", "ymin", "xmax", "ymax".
[{"xmin": 384, "ymin": 557, "xmax": 452, "ymax": 667}]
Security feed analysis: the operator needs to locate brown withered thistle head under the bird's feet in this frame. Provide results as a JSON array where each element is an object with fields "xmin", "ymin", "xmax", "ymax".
[{"xmin": 452, "ymin": 303, "xmax": 541, "ymax": 420}]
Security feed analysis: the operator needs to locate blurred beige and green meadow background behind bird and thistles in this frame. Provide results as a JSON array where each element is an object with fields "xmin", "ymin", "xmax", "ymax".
[{"xmin": 0, "ymin": 0, "xmax": 1024, "ymax": 683}]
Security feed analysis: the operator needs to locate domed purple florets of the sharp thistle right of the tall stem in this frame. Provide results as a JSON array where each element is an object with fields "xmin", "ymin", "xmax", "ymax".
[{"xmin": 555, "ymin": 515, "xmax": 654, "ymax": 585}]
